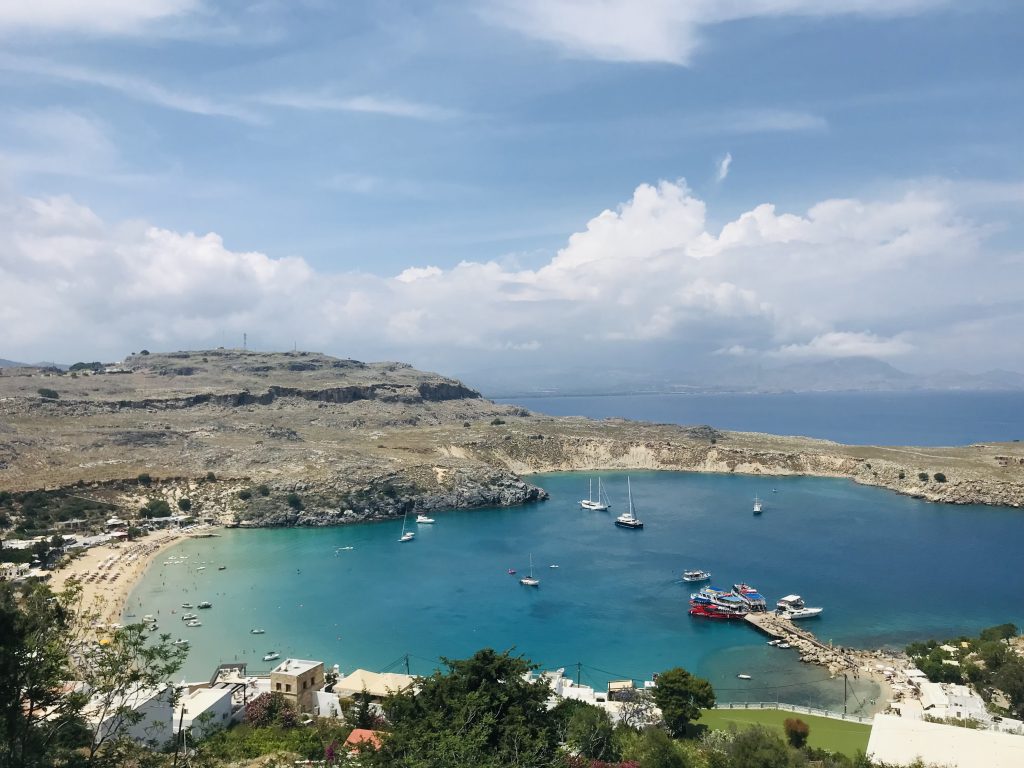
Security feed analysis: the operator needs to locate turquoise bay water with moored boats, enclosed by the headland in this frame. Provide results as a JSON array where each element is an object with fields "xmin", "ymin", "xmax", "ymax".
[{"xmin": 129, "ymin": 472, "xmax": 1024, "ymax": 707}]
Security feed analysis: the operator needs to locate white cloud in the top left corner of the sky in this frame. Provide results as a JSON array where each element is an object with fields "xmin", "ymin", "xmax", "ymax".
[{"xmin": 0, "ymin": 0, "xmax": 200, "ymax": 34}]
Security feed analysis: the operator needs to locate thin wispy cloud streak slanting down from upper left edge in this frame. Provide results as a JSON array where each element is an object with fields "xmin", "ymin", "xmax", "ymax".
[{"xmin": 0, "ymin": 53, "xmax": 259, "ymax": 123}]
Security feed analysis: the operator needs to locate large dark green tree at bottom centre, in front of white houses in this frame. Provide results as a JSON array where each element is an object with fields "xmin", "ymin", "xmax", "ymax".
[{"xmin": 362, "ymin": 648, "xmax": 558, "ymax": 768}]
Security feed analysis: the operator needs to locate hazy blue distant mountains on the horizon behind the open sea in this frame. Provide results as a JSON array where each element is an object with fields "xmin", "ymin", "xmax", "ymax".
[{"xmin": 459, "ymin": 357, "xmax": 1024, "ymax": 397}]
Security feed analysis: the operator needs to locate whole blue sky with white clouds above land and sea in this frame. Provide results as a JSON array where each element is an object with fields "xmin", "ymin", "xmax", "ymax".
[{"xmin": 0, "ymin": 0, "xmax": 1024, "ymax": 388}]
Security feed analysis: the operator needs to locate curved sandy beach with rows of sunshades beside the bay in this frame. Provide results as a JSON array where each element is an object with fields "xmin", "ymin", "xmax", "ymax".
[{"xmin": 50, "ymin": 527, "xmax": 209, "ymax": 624}]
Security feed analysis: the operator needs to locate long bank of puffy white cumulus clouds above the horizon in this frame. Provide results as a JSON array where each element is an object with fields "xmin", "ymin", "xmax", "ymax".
[{"xmin": 0, "ymin": 181, "xmax": 1024, "ymax": 371}]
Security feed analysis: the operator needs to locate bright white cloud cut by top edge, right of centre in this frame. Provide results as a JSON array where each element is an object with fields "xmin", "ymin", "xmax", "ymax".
[{"xmin": 482, "ymin": 0, "xmax": 948, "ymax": 66}]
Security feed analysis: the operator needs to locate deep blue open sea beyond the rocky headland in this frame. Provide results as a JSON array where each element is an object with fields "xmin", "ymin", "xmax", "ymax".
[{"xmin": 498, "ymin": 392, "xmax": 1024, "ymax": 445}]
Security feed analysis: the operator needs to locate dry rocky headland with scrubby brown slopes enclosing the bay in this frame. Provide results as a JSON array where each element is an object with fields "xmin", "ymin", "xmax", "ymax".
[{"xmin": 0, "ymin": 350, "xmax": 1024, "ymax": 525}]
